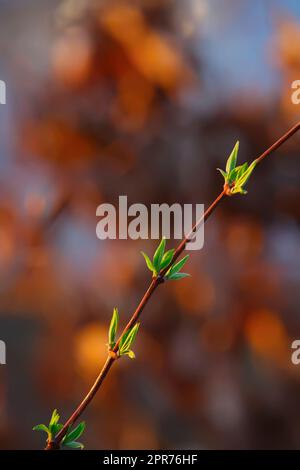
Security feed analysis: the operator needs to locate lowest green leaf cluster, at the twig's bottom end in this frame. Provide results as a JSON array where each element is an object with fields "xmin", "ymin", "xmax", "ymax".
[{"xmin": 33, "ymin": 410, "xmax": 85, "ymax": 449}]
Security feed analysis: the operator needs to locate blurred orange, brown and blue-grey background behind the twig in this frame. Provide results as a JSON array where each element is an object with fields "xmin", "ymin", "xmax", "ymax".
[{"xmin": 0, "ymin": 0, "xmax": 300, "ymax": 449}]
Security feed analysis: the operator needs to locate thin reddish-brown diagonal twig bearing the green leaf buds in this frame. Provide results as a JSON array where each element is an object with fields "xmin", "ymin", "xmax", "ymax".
[{"xmin": 46, "ymin": 122, "xmax": 300, "ymax": 450}]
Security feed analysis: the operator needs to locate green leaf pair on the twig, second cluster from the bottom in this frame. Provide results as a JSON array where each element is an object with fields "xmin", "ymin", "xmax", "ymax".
[{"xmin": 108, "ymin": 307, "xmax": 140, "ymax": 359}]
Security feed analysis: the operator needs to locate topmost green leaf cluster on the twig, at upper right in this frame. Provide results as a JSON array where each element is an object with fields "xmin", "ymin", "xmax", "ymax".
[{"xmin": 218, "ymin": 141, "xmax": 257, "ymax": 195}]
